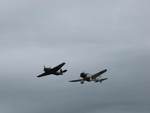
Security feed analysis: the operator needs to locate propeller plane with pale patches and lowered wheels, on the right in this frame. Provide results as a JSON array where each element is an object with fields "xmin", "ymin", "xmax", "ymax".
[{"xmin": 69, "ymin": 69, "xmax": 108, "ymax": 84}]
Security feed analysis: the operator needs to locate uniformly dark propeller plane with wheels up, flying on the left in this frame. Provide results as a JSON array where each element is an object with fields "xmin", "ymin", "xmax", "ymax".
[{"xmin": 37, "ymin": 62, "xmax": 67, "ymax": 77}]
